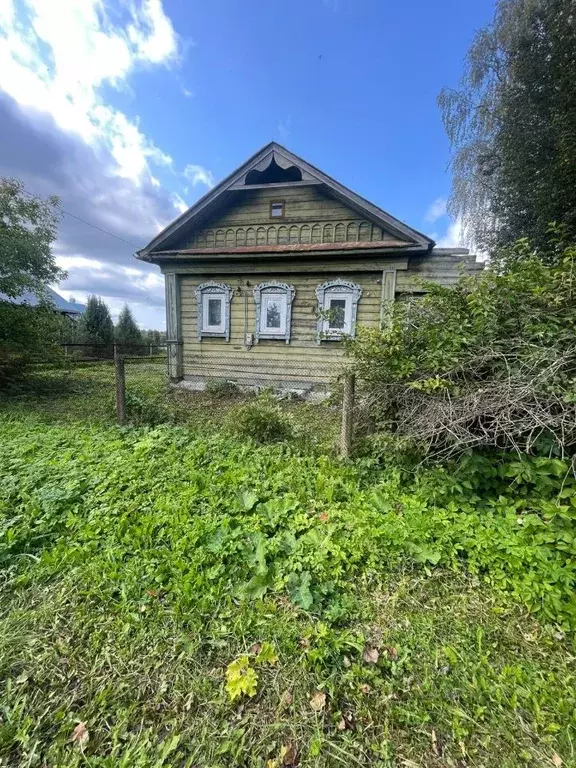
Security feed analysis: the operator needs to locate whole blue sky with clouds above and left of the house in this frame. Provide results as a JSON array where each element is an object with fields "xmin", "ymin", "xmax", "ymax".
[{"xmin": 0, "ymin": 0, "xmax": 494, "ymax": 327}]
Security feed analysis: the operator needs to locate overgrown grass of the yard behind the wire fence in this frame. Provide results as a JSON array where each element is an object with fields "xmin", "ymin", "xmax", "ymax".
[{"xmin": 0, "ymin": 358, "xmax": 339, "ymax": 451}]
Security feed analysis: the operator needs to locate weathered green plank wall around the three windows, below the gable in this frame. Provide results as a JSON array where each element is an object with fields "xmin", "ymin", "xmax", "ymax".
[{"xmin": 165, "ymin": 251, "xmax": 482, "ymax": 386}]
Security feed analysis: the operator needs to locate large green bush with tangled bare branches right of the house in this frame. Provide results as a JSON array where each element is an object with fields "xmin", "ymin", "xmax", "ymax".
[{"xmin": 349, "ymin": 231, "xmax": 576, "ymax": 456}]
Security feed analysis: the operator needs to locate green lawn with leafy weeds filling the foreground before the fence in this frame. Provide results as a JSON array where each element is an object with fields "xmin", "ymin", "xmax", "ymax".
[{"xmin": 0, "ymin": 366, "xmax": 576, "ymax": 768}]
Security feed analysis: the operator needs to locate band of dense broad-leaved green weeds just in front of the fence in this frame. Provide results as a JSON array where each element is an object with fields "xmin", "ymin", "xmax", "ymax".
[{"xmin": 0, "ymin": 426, "xmax": 576, "ymax": 629}]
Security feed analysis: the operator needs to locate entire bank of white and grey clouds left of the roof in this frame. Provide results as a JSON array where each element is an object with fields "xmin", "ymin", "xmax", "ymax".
[{"xmin": 0, "ymin": 0, "xmax": 214, "ymax": 327}]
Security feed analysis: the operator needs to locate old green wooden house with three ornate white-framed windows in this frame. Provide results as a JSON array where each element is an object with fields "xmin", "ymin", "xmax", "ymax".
[{"xmin": 137, "ymin": 143, "xmax": 481, "ymax": 391}]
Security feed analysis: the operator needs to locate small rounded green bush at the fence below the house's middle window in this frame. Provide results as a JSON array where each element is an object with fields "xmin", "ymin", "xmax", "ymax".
[{"xmin": 226, "ymin": 393, "xmax": 294, "ymax": 443}]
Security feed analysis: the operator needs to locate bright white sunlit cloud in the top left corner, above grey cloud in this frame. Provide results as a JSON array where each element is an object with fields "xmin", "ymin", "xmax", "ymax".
[{"xmin": 0, "ymin": 0, "xmax": 178, "ymax": 184}]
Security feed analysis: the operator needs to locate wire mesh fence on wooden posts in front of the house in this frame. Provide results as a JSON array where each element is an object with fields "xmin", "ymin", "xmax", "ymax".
[{"xmin": 6, "ymin": 343, "xmax": 354, "ymax": 457}]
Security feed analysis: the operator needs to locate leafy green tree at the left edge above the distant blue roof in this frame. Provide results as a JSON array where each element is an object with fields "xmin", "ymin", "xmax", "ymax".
[{"xmin": 0, "ymin": 179, "xmax": 65, "ymax": 298}]
